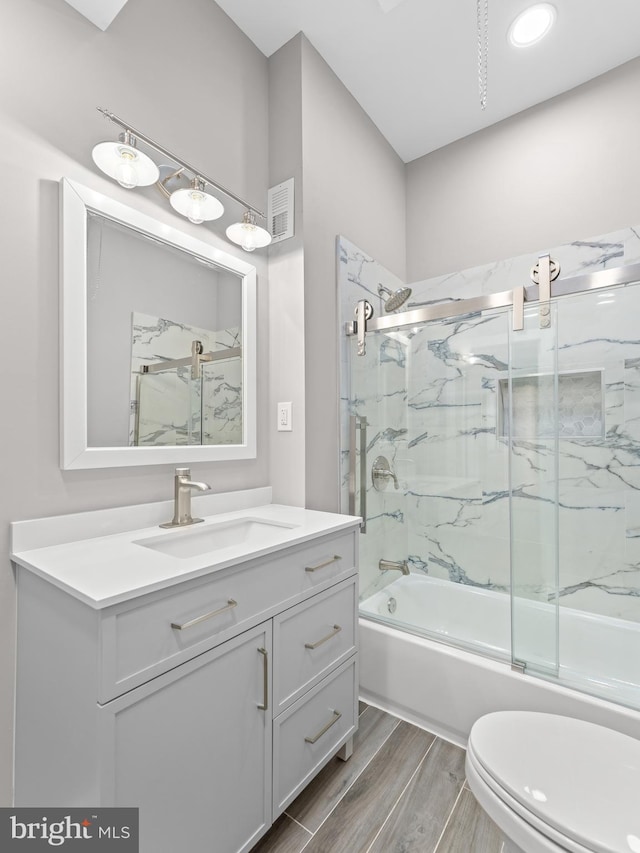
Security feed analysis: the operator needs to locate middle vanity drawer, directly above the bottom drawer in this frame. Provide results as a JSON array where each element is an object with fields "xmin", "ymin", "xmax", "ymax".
[{"xmin": 273, "ymin": 577, "xmax": 358, "ymax": 714}]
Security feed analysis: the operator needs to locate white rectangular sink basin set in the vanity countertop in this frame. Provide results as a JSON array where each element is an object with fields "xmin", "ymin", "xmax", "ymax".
[{"xmin": 133, "ymin": 518, "xmax": 298, "ymax": 559}]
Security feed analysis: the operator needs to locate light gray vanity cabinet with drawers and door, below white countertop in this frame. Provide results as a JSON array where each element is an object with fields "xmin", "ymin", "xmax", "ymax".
[{"xmin": 15, "ymin": 526, "xmax": 358, "ymax": 853}]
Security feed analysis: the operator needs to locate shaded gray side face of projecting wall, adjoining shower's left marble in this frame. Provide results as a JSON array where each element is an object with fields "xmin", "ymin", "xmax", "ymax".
[{"xmin": 301, "ymin": 38, "xmax": 406, "ymax": 511}]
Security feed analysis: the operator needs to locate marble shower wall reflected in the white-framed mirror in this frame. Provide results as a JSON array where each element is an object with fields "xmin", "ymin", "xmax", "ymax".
[{"xmin": 129, "ymin": 312, "xmax": 242, "ymax": 445}]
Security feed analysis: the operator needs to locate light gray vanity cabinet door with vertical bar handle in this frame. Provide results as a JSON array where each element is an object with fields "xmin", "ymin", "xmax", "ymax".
[{"xmin": 101, "ymin": 622, "xmax": 271, "ymax": 853}]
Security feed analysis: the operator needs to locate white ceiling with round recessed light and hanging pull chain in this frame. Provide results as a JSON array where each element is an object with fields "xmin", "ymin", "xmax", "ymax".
[{"xmin": 217, "ymin": 0, "xmax": 640, "ymax": 162}]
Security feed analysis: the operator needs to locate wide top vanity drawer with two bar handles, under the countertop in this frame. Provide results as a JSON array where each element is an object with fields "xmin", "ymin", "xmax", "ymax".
[{"xmin": 98, "ymin": 531, "xmax": 357, "ymax": 703}]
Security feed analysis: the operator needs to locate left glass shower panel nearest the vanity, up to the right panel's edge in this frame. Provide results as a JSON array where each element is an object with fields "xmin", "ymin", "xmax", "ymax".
[{"xmin": 349, "ymin": 305, "xmax": 528, "ymax": 660}]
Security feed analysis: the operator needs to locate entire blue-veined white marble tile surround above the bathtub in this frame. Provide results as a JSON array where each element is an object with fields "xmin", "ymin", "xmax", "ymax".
[{"xmin": 338, "ymin": 228, "xmax": 640, "ymax": 621}]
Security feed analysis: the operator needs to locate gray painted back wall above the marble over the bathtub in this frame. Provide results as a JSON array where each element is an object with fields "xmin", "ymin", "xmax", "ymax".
[{"xmin": 408, "ymin": 59, "xmax": 640, "ymax": 281}]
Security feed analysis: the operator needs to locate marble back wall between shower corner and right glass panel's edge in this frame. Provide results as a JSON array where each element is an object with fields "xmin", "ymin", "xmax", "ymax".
[{"xmin": 407, "ymin": 311, "xmax": 509, "ymax": 590}]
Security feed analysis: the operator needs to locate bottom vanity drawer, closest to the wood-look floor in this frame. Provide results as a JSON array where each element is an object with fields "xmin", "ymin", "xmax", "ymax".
[{"xmin": 273, "ymin": 657, "xmax": 358, "ymax": 820}]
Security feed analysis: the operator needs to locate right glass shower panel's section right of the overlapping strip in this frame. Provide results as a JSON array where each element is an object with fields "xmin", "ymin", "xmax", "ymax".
[{"xmin": 557, "ymin": 284, "xmax": 640, "ymax": 708}]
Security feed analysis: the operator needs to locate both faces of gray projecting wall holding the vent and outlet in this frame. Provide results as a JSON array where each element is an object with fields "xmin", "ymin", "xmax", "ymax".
[{"xmin": 269, "ymin": 34, "xmax": 405, "ymax": 512}]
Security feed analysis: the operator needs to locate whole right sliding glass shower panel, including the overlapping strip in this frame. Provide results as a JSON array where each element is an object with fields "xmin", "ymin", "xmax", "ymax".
[{"xmin": 504, "ymin": 276, "xmax": 640, "ymax": 708}]
